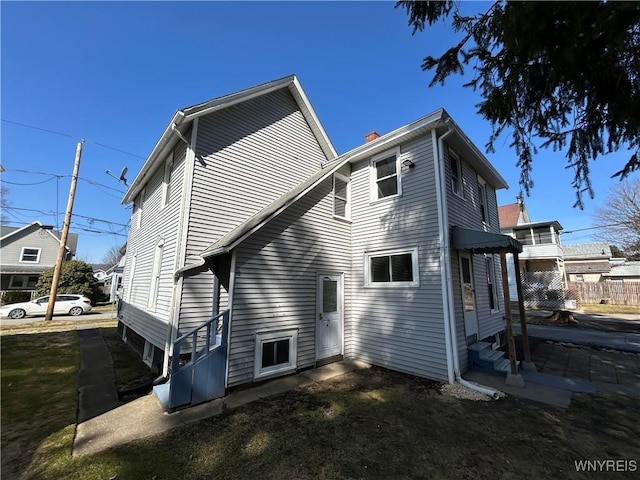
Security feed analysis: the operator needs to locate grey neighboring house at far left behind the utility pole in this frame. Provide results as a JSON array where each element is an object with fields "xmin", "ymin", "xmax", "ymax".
[{"xmin": 0, "ymin": 221, "xmax": 78, "ymax": 298}]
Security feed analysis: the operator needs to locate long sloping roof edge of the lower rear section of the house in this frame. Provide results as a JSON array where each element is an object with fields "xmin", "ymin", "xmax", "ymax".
[{"xmin": 200, "ymin": 109, "xmax": 507, "ymax": 260}]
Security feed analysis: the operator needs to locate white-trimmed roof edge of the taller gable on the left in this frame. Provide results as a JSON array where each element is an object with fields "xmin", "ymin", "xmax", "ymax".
[{"xmin": 122, "ymin": 75, "xmax": 337, "ymax": 204}]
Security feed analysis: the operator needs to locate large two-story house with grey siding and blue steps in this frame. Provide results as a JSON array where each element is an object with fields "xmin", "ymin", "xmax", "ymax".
[{"xmin": 118, "ymin": 76, "xmax": 521, "ymax": 406}]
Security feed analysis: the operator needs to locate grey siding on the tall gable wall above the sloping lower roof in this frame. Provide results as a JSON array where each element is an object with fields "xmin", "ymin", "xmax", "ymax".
[{"xmin": 180, "ymin": 89, "xmax": 332, "ymax": 331}]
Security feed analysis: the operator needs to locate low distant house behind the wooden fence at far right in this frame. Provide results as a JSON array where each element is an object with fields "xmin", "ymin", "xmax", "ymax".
[{"xmin": 562, "ymin": 242, "xmax": 613, "ymax": 282}]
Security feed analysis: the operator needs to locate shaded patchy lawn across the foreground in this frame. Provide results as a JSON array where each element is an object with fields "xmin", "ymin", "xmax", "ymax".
[{"xmin": 2, "ymin": 324, "xmax": 640, "ymax": 480}]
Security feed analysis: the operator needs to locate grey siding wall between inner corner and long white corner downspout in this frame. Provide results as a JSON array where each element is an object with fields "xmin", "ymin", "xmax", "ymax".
[{"xmin": 345, "ymin": 135, "xmax": 448, "ymax": 380}]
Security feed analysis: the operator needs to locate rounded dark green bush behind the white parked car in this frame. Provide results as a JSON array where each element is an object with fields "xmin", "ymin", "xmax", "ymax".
[{"xmin": 35, "ymin": 260, "xmax": 98, "ymax": 305}]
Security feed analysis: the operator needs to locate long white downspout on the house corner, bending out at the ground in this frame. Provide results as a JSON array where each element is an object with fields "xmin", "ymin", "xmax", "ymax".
[{"xmin": 431, "ymin": 118, "xmax": 504, "ymax": 399}]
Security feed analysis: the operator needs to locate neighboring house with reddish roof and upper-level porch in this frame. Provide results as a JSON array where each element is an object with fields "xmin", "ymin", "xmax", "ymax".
[{"xmin": 498, "ymin": 196, "xmax": 565, "ymax": 306}]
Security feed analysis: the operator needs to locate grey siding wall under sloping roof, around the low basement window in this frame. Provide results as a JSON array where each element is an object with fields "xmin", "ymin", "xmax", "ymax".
[{"xmin": 228, "ymin": 178, "xmax": 351, "ymax": 386}]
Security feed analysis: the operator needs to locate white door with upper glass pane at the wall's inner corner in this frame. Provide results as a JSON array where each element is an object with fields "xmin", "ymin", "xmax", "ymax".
[{"xmin": 316, "ymin": 275, "xmax": 342, "ymax": 360}]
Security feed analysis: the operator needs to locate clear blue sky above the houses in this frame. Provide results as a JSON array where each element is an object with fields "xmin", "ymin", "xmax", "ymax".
[{"xmin": 0, "ymin": 1, "xmax": 628, "ymax": 263}]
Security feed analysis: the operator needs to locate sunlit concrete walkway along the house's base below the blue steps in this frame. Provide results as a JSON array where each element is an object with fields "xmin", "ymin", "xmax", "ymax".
[{"xmin": 73, "ymin": 356, "xmax": 369, "ymax": 456}]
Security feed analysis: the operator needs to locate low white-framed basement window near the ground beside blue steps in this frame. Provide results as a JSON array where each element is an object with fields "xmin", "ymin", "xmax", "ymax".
[{"xmin": 254, "ymin": 330, "xmax": 298, "ymax": 378}]
